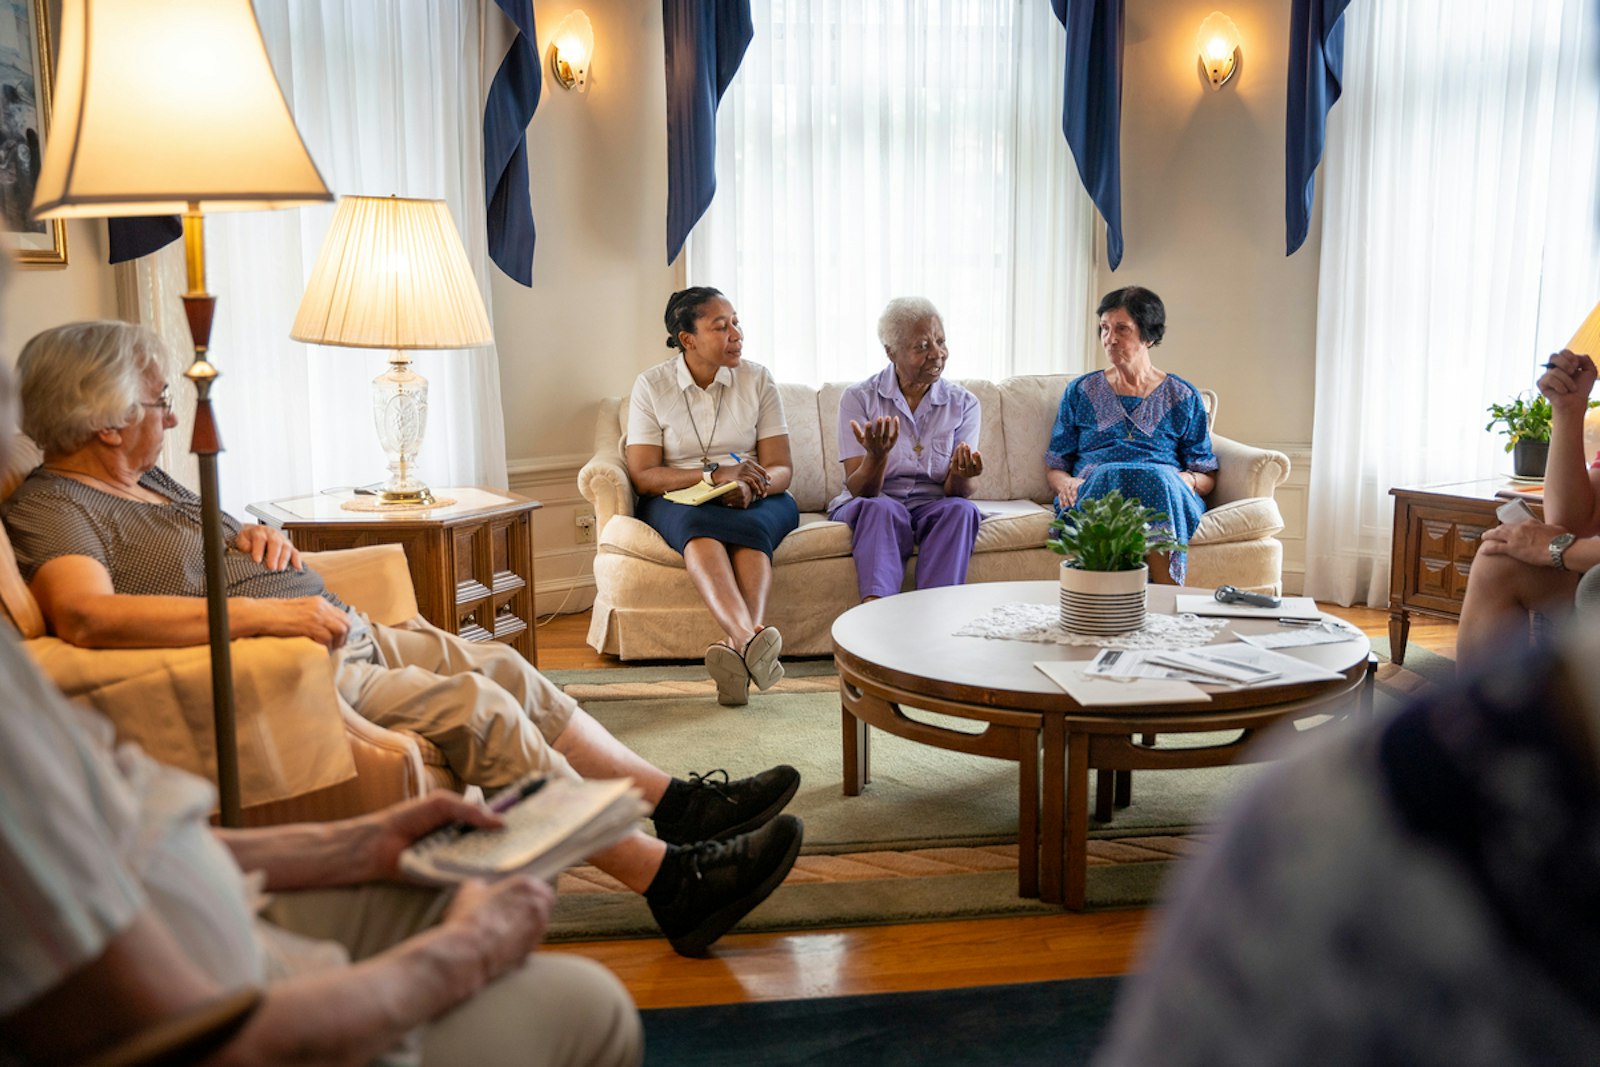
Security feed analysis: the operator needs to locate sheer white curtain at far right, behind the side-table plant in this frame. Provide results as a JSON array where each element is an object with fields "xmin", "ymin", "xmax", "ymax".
[{"xmin": 1306, "ymin": 0, "xmax": 1600, "ymax": 605}]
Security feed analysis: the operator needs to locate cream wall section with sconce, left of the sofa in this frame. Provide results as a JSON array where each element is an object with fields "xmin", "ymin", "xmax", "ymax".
[{"xmin": 491, "ymin": 0, "xmax": 682, "ymax": 611}]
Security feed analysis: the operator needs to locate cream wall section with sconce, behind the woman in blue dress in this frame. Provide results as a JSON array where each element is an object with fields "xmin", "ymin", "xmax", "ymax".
[{"xmin": 1099, "ymin": 0, "xmax": 1322, "ymax": 451}]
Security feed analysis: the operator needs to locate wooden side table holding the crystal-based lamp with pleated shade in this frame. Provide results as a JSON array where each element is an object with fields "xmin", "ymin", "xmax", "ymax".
[{"xmin": 248, "ymin": 488, "xmax": 541, "ymax": 664}]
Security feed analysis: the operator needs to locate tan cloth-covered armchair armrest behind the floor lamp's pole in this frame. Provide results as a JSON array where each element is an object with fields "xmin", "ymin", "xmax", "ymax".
[{"xmin": 22, "ymin": 637, "xmax": 355, "ymax": 808}]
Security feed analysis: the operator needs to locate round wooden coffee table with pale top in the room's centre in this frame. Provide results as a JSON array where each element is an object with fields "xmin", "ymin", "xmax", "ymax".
[{"xmin": 834, "ymin": 582, "xmax": 1371, "ymax": 909}]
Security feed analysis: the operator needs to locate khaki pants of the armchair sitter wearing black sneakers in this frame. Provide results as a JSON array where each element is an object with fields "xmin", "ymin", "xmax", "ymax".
[{"xmin": 334, "ymin": 619, "xmax": 578, "ymax": 790}]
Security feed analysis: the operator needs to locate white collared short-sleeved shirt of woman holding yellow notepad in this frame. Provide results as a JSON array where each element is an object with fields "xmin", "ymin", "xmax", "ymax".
[{"xmin": 626, "ymin": 355, "xmax": 789, "ymax": 470}]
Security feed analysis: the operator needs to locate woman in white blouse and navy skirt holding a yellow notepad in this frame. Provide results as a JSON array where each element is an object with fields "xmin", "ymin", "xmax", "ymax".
[{"xmin": 627, "ymin": 286, "xmax": 800, "ymax": 705}]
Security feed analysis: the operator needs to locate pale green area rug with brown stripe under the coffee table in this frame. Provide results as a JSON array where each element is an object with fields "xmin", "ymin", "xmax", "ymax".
[{"xmin": 550, "ymin": 641, "xmax": 1454, "ymax": 941}]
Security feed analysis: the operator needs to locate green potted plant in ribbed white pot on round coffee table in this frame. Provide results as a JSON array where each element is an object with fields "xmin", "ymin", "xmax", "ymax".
[{"xmin": 1045, "ymin": 490, "xmax": 1184, "ymax": 633}]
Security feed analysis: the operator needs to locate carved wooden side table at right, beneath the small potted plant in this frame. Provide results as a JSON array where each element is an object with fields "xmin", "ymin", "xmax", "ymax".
[{"xmin": 1389, "ymin": 478, "xmax": 1544, "ymax": 664}]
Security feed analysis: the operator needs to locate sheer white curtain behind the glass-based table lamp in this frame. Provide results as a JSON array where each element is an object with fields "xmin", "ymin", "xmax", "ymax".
[{"xmin": 196, "ymin": 0, "xmax": 506, "ymax": 515}]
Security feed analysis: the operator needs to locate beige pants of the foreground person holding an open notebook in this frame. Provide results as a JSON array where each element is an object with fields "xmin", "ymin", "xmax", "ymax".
[{"xmin": 266, "ymin": 885, "xmax": 645, "ymax": 1067}]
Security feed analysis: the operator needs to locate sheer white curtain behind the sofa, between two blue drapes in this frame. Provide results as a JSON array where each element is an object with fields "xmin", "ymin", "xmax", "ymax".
[{"xmin": 688, "ymin": 0, "xmax": 1094, "ymax": 384}]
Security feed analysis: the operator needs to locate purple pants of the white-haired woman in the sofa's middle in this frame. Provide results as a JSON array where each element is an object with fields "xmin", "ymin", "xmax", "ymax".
[{"xmin": 829, "ymin": 496, "xmax": 982, "ymax": 600}]
